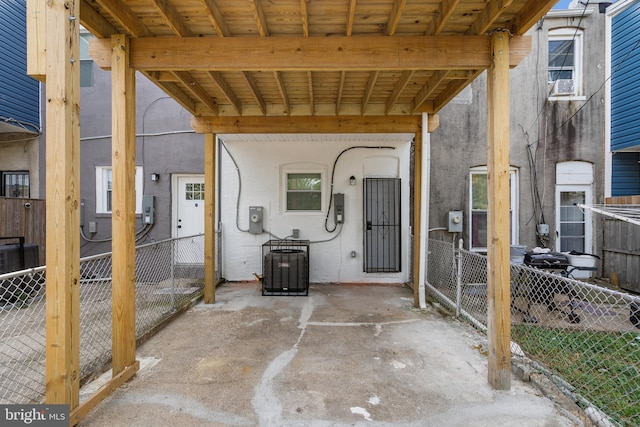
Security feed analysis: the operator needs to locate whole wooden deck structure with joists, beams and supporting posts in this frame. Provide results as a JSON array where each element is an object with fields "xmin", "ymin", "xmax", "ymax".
[{"xmin": 27, "ymin": 0, "xmax": 555, "ymax": 423}]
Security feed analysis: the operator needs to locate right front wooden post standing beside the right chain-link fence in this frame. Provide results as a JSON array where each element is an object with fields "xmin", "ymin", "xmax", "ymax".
[{"xmin": 487, "ymin": 31, "xmax": 511, "ymax": 390}]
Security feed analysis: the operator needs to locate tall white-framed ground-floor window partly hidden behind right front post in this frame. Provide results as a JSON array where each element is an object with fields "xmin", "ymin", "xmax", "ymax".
[{"xmin": 469, "ymin": 166, "xmax": 518, "ymax": 251}]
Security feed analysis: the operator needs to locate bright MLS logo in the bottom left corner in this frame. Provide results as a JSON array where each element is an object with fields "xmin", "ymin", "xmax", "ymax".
[{"xmin": 0, "ymin": 405, "xmax": 69, "ymax": 427}]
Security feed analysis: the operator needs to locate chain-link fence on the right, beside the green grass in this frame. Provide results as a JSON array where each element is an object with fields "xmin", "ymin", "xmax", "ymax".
[{"xmin": 427, "ymin": 240, "xmax": 640, "ymax": 426}]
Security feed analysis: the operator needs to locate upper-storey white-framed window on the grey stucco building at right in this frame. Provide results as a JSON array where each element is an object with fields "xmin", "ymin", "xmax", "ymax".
[{"xmin": 547, "ymin": 28, "xmax": 582, "ymax": 97}]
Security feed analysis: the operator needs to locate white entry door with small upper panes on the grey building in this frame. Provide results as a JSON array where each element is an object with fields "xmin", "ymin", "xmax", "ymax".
[{"xmin": 172, "ymin": 175, "xmax": 204, "ymax": 264}]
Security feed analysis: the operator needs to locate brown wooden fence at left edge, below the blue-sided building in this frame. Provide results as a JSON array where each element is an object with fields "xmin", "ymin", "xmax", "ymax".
[{"xmin": 0, "ymin": 197, "xmax": 46, "ymax": 265}]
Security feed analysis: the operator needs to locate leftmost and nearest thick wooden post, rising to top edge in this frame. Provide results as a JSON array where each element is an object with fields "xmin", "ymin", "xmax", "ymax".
[{"xmin": 45, "ymin": 0, "xmax": 80, "ymax": 409}]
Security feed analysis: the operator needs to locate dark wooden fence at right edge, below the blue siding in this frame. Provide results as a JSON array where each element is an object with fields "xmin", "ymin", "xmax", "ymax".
[{"xmin": 602, "ymin": 196, "xmax": 640, "ymax": 292}]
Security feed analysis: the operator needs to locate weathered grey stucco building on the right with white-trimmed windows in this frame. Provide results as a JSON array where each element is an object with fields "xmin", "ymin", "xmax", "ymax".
[{"xmin": 429, "ymin": 2, "xmax": 609, "ymax": 268}]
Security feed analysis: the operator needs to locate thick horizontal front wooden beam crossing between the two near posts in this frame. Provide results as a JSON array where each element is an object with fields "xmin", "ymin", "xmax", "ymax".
[{"xmin": 89, "ymin": 36, "xmax": 531, "ymax": 72}]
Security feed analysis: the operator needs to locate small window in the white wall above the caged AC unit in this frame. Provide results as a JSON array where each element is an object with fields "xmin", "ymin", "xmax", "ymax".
[{"xmin": 285, "ymin": 172, "xmax": 322, "ymax": 211}]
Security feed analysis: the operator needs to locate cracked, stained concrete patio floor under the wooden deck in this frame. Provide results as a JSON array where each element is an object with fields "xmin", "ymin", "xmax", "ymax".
[{"xmin": 80, "ymin": 282, "xmax": 591, "ymax": 427}]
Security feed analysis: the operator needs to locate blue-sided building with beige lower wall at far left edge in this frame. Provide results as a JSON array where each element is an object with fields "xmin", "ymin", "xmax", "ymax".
[{"xmin": 0, "ymin": 0, "xmax": 41, "ymax": 200}]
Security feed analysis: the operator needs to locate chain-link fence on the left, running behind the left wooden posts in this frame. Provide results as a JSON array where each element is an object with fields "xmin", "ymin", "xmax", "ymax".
[{"xmin": 0, "ymin": 235, "xmax": 204, "ymax": 404}]
